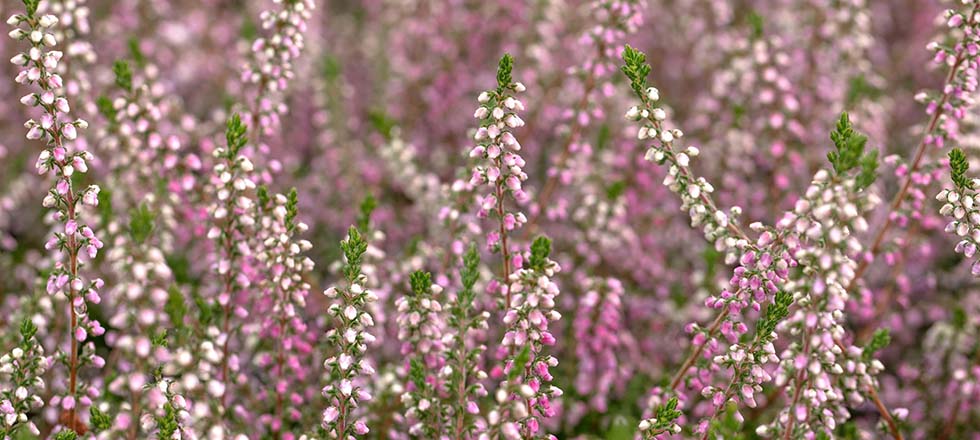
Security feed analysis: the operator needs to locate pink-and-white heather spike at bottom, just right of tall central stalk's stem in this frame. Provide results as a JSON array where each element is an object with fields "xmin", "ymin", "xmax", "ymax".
[{"xmin": 488, "ymin": 237, "xmax": 562, "ymax": 440}]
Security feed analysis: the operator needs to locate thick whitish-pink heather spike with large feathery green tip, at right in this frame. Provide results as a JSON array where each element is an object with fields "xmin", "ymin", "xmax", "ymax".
[{"xmin": 759, "ymin": 113, "xmax": 881, "ymax": 436}]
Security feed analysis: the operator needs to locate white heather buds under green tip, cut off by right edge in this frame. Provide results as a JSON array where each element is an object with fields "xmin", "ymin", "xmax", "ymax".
[{"xmin": 936, "ymin": 185, "xmax": 980, "ymax": 276}]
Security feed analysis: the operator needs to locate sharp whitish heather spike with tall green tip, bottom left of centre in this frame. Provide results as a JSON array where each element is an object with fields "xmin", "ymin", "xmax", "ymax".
[{"xmin": 321, "ymin": 226, "xmax": 377, "ymax": 439}]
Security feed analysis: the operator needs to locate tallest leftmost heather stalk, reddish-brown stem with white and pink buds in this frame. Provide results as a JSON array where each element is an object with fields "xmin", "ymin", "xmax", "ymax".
[{"xmin": 7, "ymin": 0, "xmax": 105, "ymax": 434}]
